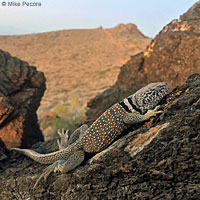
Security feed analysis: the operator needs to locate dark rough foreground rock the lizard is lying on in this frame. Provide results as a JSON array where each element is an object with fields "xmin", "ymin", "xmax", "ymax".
[{"xmin": 0, "ymin": 74, "xmax": 200, "ymax": 200}]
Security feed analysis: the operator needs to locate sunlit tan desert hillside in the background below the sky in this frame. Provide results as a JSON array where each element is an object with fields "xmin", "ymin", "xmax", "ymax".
[{"xmin": 0, "ymin": 24, "xmax": 150, "ymax": 115}]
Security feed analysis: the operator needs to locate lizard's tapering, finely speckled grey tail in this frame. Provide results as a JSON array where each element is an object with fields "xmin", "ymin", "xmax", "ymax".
[{"xmin": 10, "ymin": 142, "xmax": 80, "ymax": 164}]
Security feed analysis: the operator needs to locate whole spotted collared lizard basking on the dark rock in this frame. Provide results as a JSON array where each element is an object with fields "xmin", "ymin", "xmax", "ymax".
[{"xmin": 11, "ymin": 82, "xmax": 170, "ymax": 188}]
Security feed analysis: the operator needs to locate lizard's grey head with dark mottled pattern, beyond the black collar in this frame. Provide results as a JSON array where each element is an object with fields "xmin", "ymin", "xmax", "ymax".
[{"xmin": 132, "ymin": 82, "xmax": 169, "ymax": 113}]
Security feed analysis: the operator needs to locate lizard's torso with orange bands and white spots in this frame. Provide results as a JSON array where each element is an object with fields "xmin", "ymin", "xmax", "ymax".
[{"xmin": 81, "ymin": 104, "xmax": 128, "ymax": 153}]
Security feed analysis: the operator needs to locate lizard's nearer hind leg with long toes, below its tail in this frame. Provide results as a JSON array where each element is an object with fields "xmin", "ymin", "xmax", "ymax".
[{"xmin": 33, "ymin": 150, "xmax": 85, "ymax": 189}]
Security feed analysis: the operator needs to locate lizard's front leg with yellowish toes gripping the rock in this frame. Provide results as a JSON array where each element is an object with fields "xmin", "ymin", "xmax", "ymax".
[{"xmin": 123, "ymin": 106, "xmax": 163, "ymax": 124}]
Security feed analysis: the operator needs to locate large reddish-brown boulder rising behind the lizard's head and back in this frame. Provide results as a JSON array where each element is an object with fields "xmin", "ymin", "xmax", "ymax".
[{"xmin": 87, "ymin": 1, "xmax": 200, "ymax": 120}]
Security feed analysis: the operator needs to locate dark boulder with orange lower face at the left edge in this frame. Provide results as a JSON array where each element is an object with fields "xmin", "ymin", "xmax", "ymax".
[{"xmin": 0, "ymin": 50, "xmax": 45, "ymax": 148}]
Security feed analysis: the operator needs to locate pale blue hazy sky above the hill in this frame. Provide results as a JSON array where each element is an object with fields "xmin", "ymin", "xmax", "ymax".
[{"xmin": 0, "ymin": 0, "xmax": 197, "ymax": 37}]
